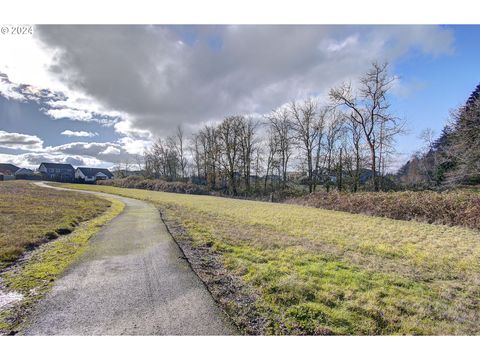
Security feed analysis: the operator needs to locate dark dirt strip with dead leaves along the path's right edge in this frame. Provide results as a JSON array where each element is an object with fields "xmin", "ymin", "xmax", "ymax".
[{"xmin": 159, "ymin": 209, "xmax": 266, "ymax": 335}]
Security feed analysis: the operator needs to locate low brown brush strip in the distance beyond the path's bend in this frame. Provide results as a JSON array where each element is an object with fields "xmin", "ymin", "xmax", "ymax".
[{"xmin": 97, "ymin": 176, "xmax": 210, "ymax": 195}]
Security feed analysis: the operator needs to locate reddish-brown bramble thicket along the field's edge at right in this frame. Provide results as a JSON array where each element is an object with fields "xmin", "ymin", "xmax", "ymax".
[{"xmin": 287, "ymin": 190, "xmax": 480, "ymax": 229}]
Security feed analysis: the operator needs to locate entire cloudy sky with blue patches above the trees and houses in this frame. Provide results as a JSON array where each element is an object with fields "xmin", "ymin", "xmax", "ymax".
[{"xmin": 0, "ymin": 25, "xmax": 480, "ymax": 168}]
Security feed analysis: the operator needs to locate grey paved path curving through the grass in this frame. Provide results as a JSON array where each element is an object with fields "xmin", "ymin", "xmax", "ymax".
[{"xmin": 23, "ymin": 185, "xmax": 235, "ymax": 335}]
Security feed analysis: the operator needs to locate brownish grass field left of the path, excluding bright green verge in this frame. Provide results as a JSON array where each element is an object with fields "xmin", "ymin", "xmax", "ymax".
[{"xmin": 0, "ymin": 181, "xmax": 110, "ymax": 269}]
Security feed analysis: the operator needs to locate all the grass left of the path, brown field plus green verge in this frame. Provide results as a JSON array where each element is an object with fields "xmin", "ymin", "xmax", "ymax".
[{"xmin": 0, "ymin": 181, "xmax": 124, "ymax": 335}]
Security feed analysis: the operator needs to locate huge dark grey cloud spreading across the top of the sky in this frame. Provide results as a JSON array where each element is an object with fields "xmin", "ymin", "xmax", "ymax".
[{"xmin": 36, "ymin": 25, "xmax": 453, "ymax": 135}]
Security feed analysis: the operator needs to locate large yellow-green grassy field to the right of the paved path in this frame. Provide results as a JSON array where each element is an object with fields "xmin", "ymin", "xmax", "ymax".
[{"xmin": 61, "ymin": 185, "xmax": 480, "ymax": 334}]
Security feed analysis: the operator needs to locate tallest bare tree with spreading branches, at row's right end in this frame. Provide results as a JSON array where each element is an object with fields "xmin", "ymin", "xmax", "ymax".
[{"xmin": 330, "ymin": 63, "xmax": 402, "ymax": 191}]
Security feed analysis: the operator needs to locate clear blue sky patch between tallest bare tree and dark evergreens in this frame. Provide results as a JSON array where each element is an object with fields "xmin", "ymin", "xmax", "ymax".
[{"xmin": 392, "ymin": 25, "xmax": 480, "ymax": 158}]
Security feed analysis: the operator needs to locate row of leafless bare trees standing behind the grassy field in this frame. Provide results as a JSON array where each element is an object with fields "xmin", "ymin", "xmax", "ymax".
[{"xmin": 143, "ymin": 63, "xmax": 403, "ymax": 195}]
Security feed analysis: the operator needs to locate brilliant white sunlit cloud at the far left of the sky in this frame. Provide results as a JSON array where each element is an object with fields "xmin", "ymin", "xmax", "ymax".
[{"xmin": 0, "ymin": 27, "xmax": 122, "ymax": 129}]
